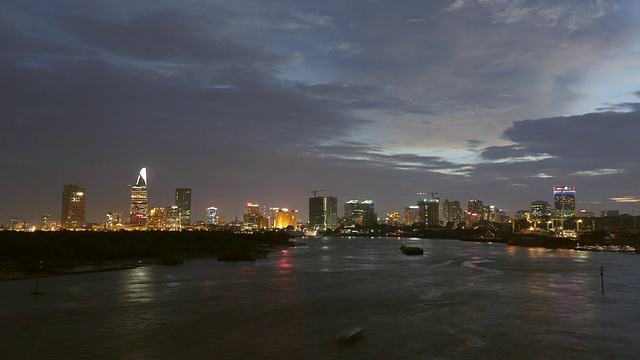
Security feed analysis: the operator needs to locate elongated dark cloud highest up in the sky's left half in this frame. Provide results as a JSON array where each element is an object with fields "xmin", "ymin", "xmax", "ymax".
[{"xmin": 59, "ymin": 9, "xmax": 278, "ymax": 71}]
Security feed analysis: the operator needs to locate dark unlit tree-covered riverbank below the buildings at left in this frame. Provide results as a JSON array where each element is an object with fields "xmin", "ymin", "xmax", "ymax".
[{"xmin": 0, "ymin": 231, "xmax": 289, "ymax": 275}]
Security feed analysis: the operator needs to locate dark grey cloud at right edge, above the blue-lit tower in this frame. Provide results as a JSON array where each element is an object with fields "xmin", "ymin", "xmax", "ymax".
[{"xmin": 481, "ymin": 107, "xmax": 640, "ymax": 178}]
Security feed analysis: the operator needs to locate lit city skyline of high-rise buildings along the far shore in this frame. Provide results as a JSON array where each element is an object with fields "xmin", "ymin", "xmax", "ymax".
[{"xmin": 0, "ymin": 167, "xmax": 637, "ymax": 228}]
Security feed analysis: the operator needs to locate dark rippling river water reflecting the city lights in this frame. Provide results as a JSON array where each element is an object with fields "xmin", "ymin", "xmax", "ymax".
[{"xmin": 0, "ymin": 238, "xmax": 640, "ymax": 359}]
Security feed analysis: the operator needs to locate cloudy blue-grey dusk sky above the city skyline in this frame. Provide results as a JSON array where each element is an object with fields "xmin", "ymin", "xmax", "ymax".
[{"xmin": 0, "ymin": 0, "xmax": 640, "ymax": 224}]
